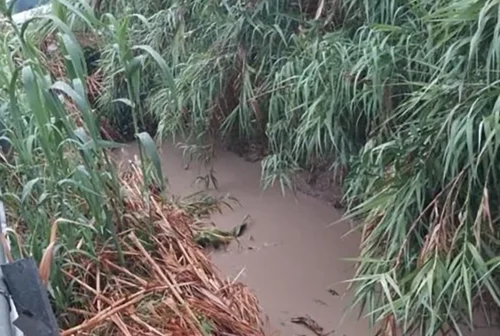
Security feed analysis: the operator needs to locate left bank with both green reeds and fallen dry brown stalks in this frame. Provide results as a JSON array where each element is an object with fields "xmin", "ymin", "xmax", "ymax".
[{"xmin": 0, "ymin": 1, "xmax": 262, "ymax": 336}]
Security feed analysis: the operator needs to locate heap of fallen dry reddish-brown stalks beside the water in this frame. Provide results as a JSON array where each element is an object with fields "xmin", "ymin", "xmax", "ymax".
[{"xmin": 61, "ymin": 166, "xmax": 264, "ymax": 336}]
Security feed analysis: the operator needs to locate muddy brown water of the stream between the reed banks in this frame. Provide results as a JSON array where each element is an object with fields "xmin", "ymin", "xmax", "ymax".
[{"xmin": 120, "ymin": 144, "xmax": 498, "ymax": 336}]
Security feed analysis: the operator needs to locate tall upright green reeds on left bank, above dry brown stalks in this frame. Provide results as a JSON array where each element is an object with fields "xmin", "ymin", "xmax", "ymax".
[{"xmin": 0, "ymin": 0, "xmax": 168, "ymax": 327}]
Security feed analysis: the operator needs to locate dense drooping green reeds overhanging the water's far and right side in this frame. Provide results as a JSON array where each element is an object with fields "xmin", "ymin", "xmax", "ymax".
[{"xmin": 89, "ymin": 0, "xmax": 500, "ymax": 335}]
